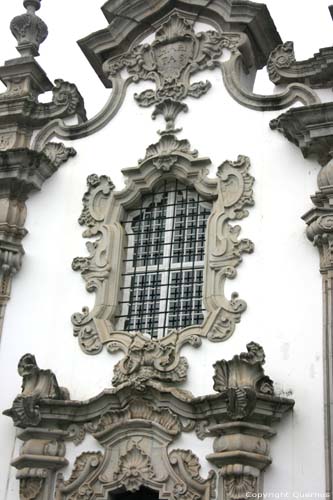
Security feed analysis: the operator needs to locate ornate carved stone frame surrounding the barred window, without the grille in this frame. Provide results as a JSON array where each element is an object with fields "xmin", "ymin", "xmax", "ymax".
[{"xmin": 72, "ymin": 134, "xmax": 253, "ymax": 386}]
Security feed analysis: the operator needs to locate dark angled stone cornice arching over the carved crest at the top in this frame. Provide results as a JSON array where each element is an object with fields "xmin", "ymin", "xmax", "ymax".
[{"xmin": 78, "ymin": 0, "xmax": 282, "ymax": 87}]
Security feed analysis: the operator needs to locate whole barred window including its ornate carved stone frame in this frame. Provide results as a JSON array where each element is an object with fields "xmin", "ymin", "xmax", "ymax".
[{"xmin": 72, "ymin": 131, "xmax": 253, "ymax": 383}]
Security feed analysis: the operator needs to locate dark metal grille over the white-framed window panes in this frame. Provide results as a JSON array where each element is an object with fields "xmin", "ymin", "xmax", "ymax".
[{"xmin": 117, "ymin": 181, "xmax": 211, "ymax": 338}]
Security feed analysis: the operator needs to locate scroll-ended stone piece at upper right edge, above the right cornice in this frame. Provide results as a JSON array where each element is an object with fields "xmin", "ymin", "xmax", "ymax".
[{"xmin": 267, "ymin": 42, "xmax": 333, "ymax": 88}]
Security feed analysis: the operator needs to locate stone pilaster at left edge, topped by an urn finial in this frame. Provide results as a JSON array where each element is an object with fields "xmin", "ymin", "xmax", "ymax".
[{"xmin": 0, "ymin": 0, "xmax": 86, "ymax": 334}]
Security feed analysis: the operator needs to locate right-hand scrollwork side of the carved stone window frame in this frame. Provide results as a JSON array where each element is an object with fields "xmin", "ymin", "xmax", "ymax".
[{"xmin": 205, "ymin": 156, "xmax": 254, "ymax": 341}]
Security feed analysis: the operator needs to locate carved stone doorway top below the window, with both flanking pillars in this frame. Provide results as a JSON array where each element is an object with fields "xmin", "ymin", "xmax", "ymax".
[{"xmin": 6, "ymin": 342, "xmax": 294, "ymax": 500}]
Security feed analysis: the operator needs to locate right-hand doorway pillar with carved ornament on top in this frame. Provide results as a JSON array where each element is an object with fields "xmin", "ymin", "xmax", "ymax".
[{"xmin": 207, "ymin": 342, "xmax": 288, "ymax": 500}]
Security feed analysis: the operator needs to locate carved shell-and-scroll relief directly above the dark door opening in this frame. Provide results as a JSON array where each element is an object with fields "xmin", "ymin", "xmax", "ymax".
[{"xmin": 57, "ymin": 442, "xmax": 215, "ymax": 500}]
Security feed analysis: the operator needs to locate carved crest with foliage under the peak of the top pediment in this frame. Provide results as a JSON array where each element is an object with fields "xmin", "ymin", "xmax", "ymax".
[{"xmin": 104, "ymin": 13, "xmax": 236, "ymax": 129}]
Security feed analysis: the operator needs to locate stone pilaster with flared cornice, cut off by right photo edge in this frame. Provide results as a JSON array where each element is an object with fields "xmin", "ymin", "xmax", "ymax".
[{"xmin": 271, "ymin": 97, "xmax": 333, "ymax": 494}]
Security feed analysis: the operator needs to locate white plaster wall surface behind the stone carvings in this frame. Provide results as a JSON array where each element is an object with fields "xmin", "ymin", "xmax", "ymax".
[{"xmin": 0, "ymin": 0, "xmax": 332, "ymax": 500}]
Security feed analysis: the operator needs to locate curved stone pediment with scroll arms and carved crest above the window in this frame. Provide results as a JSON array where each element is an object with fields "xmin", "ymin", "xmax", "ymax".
[{"xmin": 34, "ymin": 0, "xmax": 320, "ymax": 150}]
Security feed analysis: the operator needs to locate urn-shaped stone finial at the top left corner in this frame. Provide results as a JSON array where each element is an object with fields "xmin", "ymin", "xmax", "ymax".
[{"xmin": 10, "ymin": 0, "xmax": 48, "ymax": 57}]
